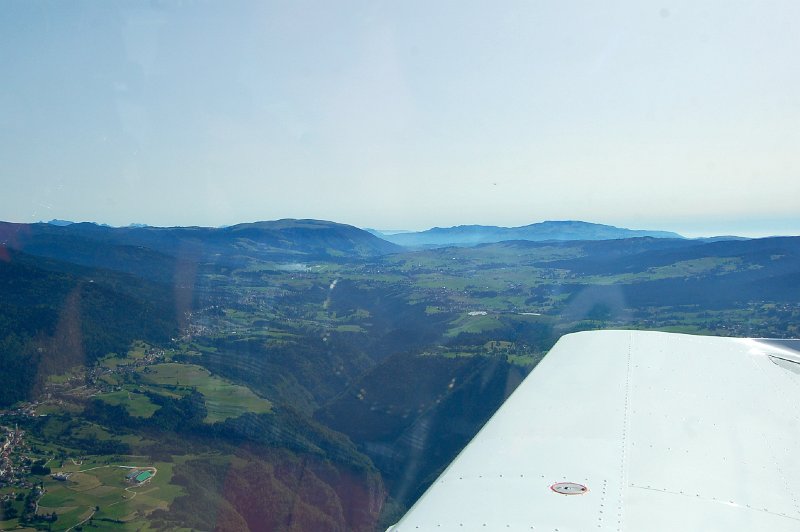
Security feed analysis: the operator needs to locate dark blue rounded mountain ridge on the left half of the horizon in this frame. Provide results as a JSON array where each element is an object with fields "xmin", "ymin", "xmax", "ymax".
[{"xmin": 0, "ymin": 219, "xmax": 402, "ymax": 282}]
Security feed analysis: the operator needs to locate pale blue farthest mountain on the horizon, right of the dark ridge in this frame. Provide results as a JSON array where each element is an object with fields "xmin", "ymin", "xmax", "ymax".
[{"xmin": 369, "ymin": 221, "xmax": 684, "ymax": 248}]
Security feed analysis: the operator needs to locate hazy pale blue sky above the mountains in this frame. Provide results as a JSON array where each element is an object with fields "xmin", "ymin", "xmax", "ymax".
[{"xmin": 0, "ymin": 0, "xmax": 800, "ymax": 235}]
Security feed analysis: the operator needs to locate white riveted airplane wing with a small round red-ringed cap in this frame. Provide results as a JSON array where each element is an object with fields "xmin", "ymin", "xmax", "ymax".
[{"xmin": 389, "ymin": 331, "xmax": 800, "ymax": 532}]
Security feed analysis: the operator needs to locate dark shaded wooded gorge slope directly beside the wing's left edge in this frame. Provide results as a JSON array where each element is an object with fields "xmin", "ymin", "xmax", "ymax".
[{"xmin": 316, "ymin": 354, "xmax": 526, "ymax": 506}]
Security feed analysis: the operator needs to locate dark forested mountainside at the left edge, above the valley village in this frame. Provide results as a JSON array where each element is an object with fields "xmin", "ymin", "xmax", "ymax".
[{"xmin": 0, "ymin": 247, "xmax": 178, "ymax": 407}]
